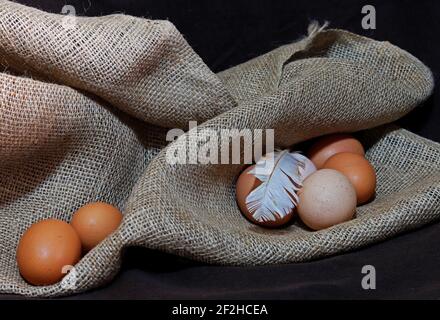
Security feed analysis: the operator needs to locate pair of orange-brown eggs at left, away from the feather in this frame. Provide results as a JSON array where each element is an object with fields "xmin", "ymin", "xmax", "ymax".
[{"xmin": 16, "ymin": 202, "xmax": 122, "ymax": 285}]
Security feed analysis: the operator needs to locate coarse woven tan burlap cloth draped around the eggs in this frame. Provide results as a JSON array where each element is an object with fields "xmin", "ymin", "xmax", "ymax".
[{"xmin": 0, "ymin": 0, "xmax": 440, "ymax": 296}]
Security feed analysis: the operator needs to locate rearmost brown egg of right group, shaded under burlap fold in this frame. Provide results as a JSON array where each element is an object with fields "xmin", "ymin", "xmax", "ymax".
[{"xmin": 307, "ymin": 133, "xmax": 365, "ymax": 169}]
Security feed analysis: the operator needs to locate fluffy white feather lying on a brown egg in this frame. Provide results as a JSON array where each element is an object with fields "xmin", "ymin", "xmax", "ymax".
[{"xmin": 246, "ymin": 150, "xmax": 316, "ymax": 222}]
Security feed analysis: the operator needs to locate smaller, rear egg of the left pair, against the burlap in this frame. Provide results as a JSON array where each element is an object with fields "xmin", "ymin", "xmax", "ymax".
[{"xmin": 70, "ymin": 202, "xmax": 122, "ymax": 252}]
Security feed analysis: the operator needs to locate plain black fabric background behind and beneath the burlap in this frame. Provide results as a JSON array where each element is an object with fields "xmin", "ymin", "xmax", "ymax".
[{"xmin": 0, "ymin": 0, "xmax": 440, "ymax": 299}]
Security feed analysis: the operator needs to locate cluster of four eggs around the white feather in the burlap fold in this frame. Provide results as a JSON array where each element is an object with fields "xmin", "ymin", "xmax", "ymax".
[{"xmin": 236, "ymin": 134, "xmax": 376, "ymax": 230}]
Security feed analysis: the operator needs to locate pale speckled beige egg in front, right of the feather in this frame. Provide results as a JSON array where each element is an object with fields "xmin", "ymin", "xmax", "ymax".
[{"xmin": 297, "ymin": 169, "xmax": 356, "ymax": 230}]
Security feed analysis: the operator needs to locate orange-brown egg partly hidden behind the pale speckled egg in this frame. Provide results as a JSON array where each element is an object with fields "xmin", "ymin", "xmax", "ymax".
[{"xmin": 324, "ymin": 152, "xmax": 376, "ymax": 204}]
